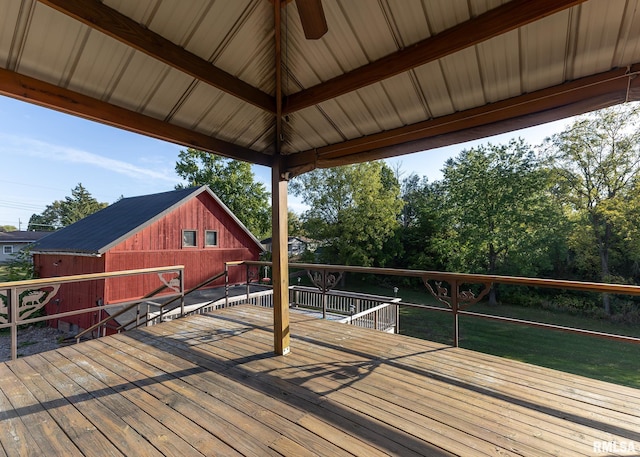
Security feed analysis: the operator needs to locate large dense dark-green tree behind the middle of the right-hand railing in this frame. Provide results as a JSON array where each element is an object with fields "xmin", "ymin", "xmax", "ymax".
[{"xmin": 437, "ymin": 139, "xmax": 564, "ymax": 303}]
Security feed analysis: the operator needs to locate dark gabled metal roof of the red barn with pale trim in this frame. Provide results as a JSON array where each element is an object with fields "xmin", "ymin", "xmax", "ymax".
[{"xmin": 33, "ymin": 186, "xmax": 262, "ymax": 255}]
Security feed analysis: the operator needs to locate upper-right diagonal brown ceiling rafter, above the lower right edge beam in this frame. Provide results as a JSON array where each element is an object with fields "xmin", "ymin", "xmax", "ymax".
[{"xmin": 283, "ymin": 0, "xmax": 586, "ymax": 114}]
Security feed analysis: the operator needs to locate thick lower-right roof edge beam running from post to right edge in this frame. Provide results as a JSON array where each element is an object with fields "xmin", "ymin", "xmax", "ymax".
[{"xmin": 286, "ymin": 63, "xmax": 640, "ymax": 176}]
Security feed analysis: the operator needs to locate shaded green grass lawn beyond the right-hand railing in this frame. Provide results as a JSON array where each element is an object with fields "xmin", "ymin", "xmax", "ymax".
[{"xmin": 340, "ymin": 274, "xmax": 640, "ymax": 388}]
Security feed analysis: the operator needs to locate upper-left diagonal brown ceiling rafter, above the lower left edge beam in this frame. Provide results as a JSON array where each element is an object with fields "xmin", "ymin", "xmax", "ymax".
[{"xmin": 39, "ymin": 0, "xmax": 275, "ymax": 113}]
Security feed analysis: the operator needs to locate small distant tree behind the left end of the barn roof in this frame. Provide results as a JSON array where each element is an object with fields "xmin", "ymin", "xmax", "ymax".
[{"xmin": 28, "ymin": 183, "xmax": 108, "ymax": 231}]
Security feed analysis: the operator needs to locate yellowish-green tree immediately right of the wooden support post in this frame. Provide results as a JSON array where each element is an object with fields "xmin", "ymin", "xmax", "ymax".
[{"xmin": 290, "ymin": 162, "xmax": 402, "ymax": 266}]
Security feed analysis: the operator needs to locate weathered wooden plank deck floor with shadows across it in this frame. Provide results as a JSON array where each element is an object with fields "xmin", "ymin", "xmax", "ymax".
[{"xmin": 0, "ymin": 306, "xmax": 640, "ymax": 457}]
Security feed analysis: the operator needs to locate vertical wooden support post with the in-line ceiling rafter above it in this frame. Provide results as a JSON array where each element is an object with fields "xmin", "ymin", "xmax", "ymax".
[{"xmin": 271, "ymin": 0, "xmax": 291, "ymax": 355}]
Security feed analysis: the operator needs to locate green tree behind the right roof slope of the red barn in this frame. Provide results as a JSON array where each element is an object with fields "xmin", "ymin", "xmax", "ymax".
[{"xmin": 176, "ymin": 148, "xmax": 271, "ymax": 238}]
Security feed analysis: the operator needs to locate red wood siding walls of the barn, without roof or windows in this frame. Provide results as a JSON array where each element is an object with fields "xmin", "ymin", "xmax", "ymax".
[{"xmin": 34, "ymin": 192, "xmax": 261, "ymax": 328}]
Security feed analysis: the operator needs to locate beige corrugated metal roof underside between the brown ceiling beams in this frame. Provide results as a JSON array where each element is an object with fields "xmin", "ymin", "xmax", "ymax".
[{"xmin": 0, "ymin": 0, "xmax": 640, "ymax": 173}]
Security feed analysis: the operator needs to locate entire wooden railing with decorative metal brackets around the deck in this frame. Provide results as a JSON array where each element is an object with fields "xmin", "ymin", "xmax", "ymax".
[{"xmin": 5, "ymin": 261, "xmax": 640, "ymax": 359}]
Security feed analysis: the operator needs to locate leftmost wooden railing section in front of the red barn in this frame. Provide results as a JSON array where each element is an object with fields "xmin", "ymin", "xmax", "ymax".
[{"xmin": 0, "ymin": 265, "xmax": 184, "ymax": 359}]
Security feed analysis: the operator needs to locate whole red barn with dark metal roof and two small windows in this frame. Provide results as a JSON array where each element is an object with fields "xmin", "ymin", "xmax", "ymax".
[{"xmin": 32, "ymin": 186, "xmax": 263, "ymax": 330}]
